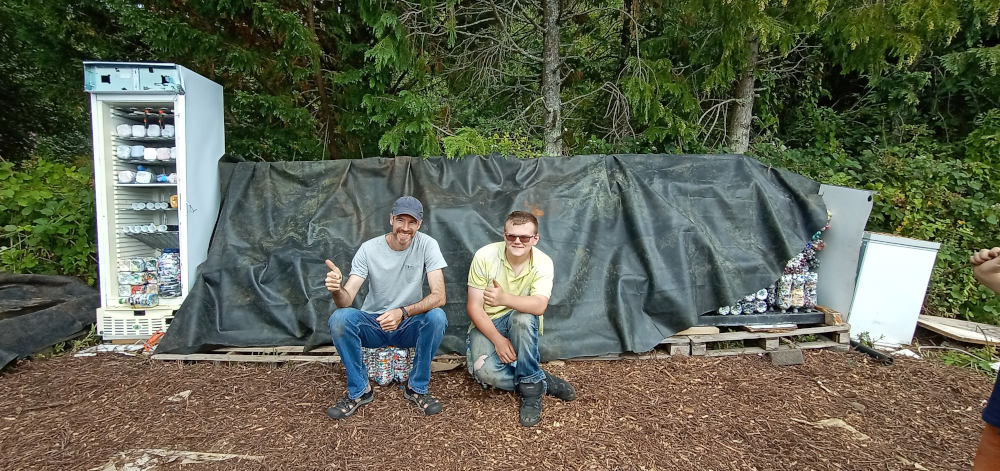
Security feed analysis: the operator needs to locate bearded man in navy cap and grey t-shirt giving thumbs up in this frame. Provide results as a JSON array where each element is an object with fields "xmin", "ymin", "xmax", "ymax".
[{"xmin": 325, "ymin": 196, "xmax": 448, "ymax": 419}]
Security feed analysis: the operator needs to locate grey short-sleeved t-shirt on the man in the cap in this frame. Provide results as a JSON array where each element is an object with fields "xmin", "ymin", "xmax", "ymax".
[{"xmin": 351, "ymin": 232, "xmax": 448, "ymax": 314}]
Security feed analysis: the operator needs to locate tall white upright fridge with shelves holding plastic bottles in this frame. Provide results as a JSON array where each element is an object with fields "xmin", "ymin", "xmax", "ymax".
[{"xmin": 83, "ymin": 62, "xmax": 225, "ymax": 340}]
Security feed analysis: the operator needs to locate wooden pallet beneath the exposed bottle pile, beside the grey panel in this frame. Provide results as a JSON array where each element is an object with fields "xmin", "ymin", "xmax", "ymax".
[{"xmin": 660, "ymin": 324, "xmax": 851, "ymax": 356}]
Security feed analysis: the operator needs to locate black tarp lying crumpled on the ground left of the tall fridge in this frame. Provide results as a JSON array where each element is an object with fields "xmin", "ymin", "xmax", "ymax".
[{"xmin": 0, "ymin": 273, "xmax": 101, "ymax": 368}]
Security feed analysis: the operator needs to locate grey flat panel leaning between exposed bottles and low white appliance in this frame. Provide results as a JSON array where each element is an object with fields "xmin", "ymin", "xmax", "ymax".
[{"xmin": 816, "ymin": 185, "xmax": 874, "ymax": 317}]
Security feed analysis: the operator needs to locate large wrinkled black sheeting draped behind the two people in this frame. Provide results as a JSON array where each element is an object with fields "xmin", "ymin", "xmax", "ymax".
[{"xmin": 158, "ymin": 155, "xmax": 827, "ymax": 360}]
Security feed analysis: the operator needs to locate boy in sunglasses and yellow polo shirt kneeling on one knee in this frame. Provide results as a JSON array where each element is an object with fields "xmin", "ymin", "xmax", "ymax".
[{"xmin": 466, "ymin": 211, "xmax": 576, "ymax": 427}]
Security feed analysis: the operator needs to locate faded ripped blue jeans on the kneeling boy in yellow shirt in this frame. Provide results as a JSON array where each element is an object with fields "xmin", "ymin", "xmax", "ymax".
[{"xmin": 467, "ymin": 310, "xmax": 545, "ymax": 391}]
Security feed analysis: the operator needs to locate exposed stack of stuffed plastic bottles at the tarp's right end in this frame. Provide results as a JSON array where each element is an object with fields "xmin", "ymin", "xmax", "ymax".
[{"xmin": 716, "ymin": 224, "xmax": 830, "ymax": 316}]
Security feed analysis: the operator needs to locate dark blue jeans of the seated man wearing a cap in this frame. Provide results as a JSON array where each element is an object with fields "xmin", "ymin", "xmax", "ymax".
[{"xmin": 330, "ymin": 307, "xmax": 448, "ymax": 399}]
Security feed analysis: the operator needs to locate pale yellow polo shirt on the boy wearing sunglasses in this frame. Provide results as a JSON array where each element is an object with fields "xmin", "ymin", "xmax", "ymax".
[{"xmin": 468, "ymin": 241, "xmax": 555, "ymax": 332}]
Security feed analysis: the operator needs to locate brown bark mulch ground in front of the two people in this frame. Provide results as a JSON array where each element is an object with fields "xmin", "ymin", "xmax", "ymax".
[{"xmin": 0, "ymin": 351, "xmax": 992, "ymax": 470}]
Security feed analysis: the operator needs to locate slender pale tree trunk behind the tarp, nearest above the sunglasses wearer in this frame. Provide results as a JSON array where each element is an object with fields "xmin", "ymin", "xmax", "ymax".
[{"xmin": 542, "ymin": 0, "xmax": 563, "ymax": 155}]
